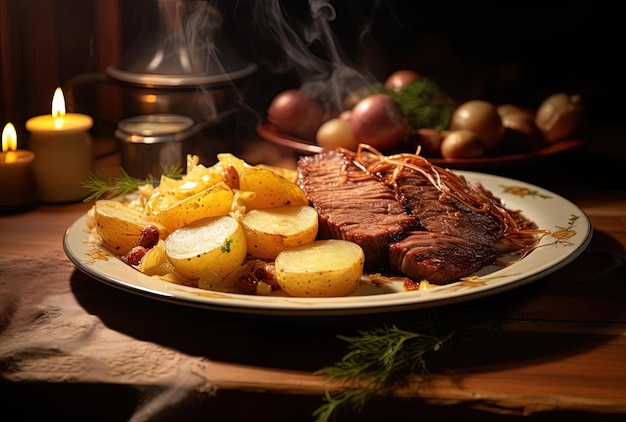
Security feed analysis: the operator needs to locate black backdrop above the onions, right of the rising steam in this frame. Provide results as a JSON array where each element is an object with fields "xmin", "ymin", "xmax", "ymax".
[{"xmin": 233, "ymin": 0, "xmax": 626, "ymax": 125}]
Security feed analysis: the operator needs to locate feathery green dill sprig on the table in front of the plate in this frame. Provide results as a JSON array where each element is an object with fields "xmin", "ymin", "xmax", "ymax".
[{"xmin": 313, "ymin": 310, "xmax": 501, "ymax": 422}]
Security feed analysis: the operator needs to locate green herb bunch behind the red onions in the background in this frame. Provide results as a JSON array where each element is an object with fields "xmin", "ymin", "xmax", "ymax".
[{"xmin": 384, "ymin": 78, "xmax": 454, "ymax": 132}]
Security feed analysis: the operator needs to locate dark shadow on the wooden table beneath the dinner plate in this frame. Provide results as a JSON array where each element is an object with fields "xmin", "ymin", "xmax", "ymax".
[{"xmin": 71, "ymin": 227, "xmax": 626, "ymax": 371}]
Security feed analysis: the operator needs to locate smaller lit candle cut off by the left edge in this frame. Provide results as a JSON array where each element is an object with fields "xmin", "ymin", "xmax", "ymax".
[{"xmin": 0, "ymin": 123, "xmax": 37, "ymax": 211}]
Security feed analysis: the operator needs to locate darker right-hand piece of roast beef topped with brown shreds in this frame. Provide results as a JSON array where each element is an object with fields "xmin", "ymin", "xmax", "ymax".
[{"xmin": 370, "ymin": 163, "xmax": 504, "ymax": 283}]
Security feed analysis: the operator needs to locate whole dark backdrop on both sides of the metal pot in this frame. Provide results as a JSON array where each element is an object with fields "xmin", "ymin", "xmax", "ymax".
[{"xmin": 0, "ymin": 0, "xmax": 626, "ymax": 143}]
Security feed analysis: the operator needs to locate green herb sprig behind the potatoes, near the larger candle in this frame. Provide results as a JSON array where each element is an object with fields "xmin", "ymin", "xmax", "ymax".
[{"xmin": 81, "ymin": 166, "xmax": 182, "ymax": 202}]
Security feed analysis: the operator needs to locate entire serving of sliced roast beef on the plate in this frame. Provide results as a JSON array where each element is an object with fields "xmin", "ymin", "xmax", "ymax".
[{"xmin": 298, "ymin": 151, "xmax": 521, "ymax": 283}]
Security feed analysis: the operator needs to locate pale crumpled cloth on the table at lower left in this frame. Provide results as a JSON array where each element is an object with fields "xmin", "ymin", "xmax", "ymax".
[{"xmin": 0, "ymin": 248, "xmax": 216, "ymax": 421}]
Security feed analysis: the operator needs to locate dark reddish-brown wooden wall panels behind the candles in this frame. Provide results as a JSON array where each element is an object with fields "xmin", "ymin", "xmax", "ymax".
[{"xmin": 0, "ymin": 0, "xmax": 121, "ymax": 146}]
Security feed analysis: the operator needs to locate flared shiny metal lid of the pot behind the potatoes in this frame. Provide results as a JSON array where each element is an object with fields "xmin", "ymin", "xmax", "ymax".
[{"xmin": 106, "ymin": 0, "xmax": 257, "ymax": 87}]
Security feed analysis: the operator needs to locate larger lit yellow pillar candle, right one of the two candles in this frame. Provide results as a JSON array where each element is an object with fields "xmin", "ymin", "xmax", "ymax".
[{"xmin": 26, "ymin": 88, "xmax": 93, "ymax": 203}]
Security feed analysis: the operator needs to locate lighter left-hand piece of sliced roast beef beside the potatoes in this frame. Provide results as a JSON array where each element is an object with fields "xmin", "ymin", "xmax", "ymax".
[{"xmin": 298, "ymin": 151, "xmax": 418, "ymax": 271}]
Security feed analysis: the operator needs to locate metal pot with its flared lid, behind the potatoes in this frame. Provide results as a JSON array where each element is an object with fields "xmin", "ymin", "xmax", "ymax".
[{"xmin": 64, "ymin": 0, "xmax": 257, "ymax": 167}]
